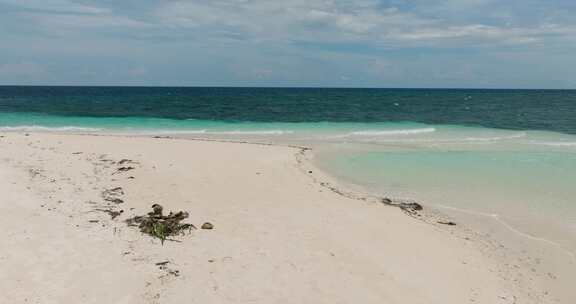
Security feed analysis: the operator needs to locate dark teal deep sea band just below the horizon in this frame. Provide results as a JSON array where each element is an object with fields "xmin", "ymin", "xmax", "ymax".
[{"xmin": 0, "ymin": 87, "xmax": 576, "ymax": 134}]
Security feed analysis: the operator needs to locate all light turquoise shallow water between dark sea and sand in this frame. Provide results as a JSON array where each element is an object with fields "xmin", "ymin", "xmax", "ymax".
[{"xmin": 0, "ymin": 113, "xmax": 576, "ymax": 235}]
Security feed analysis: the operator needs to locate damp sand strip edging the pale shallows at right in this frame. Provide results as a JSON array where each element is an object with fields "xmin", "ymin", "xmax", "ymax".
[{"xmin": 309, "ymin": 145, "xmax": 576, "ymax": 303}]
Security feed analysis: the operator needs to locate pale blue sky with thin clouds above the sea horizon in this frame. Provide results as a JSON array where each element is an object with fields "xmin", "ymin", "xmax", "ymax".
[{"xmin": 0, "ymin": 0, "xmax": 576, "ymax": 89}]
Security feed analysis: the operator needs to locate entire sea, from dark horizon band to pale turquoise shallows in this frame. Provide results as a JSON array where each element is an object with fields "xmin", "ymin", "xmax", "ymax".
[{"xmin": 0, "ymin": 86, "xmax": 576, "ymax": 258}]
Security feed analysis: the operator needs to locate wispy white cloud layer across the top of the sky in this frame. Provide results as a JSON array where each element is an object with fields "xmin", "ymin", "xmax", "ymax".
[{"xmin": 5, "ymin": 0, "xmax": 576, "ymax": 48}]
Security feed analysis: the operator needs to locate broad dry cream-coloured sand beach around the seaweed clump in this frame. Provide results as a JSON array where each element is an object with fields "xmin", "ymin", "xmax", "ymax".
[{"xmin": 0, "ymin": 133, "xmax": 555, "ymax": 304}]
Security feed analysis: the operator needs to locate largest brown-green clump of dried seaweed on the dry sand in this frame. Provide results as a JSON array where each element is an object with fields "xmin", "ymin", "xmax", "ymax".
[{"xmin": 126, "ymin": 204, "xmax": 196, "ymax": 244}]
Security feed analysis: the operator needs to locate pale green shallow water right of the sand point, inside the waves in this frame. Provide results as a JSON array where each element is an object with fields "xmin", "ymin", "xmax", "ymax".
[{"xmin": 308, "ymin": 125, "xmax": 576, "ymax": 256}]
